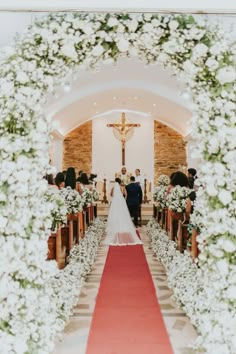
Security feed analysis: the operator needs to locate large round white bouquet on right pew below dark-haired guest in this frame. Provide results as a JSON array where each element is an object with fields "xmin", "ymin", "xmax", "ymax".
[{"xmin": 166, "ymin": 186, "xmax": 192, "ymax": 213}]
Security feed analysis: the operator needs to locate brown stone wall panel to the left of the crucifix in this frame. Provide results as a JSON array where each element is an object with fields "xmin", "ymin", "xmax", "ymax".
[{"xmin": 63, "ymin": 121, "xmax": 92, "ymax": 173}]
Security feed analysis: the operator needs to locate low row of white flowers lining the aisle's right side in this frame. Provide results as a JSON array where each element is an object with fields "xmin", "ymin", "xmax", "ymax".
[{"xmin": 146, "ymin": 219, "xmax": 207, "ymax": 342}]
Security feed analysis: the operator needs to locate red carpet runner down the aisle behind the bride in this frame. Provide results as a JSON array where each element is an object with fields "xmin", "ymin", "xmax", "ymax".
[{"xmin": 86, "ymin": 238, "xmax": 173, "ymax": 354}]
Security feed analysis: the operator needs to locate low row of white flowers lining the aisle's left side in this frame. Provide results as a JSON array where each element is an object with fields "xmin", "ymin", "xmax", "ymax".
[{"xmin": 48, "ymin": 218, "xmax": 105, "ymax": 334}]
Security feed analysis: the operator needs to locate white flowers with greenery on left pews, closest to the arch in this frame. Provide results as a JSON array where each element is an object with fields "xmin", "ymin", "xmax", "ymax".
[{"xmin": 45, "ymin": 188, "xmax": 67, "ymax": 231}]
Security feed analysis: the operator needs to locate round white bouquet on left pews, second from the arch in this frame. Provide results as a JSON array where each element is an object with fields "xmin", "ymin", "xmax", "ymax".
[{"xmin": 60, "ymin": 187, "xmax": 84, "ymax": 214}]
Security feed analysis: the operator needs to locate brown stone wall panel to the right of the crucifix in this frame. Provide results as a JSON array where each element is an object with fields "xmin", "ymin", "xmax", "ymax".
[{"xmin": 154, "ymin": 121, "xmax": 187, "ymax": 185}]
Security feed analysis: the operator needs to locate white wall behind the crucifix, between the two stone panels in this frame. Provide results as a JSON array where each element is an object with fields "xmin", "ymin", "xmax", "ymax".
[{"xmin": 92, "ymin": 112, "xmax": 154, "ymax": 181}]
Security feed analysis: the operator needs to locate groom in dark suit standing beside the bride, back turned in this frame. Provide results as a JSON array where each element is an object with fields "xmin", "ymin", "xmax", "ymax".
[{"xmin": 125, "ymin": 176, "xmax": 143, "ymax": 227}]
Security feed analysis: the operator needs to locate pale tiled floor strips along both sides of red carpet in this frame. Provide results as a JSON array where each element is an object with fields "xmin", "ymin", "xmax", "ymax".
[{"xmin": 53, "ymin": 228, "xmax": 196, "ymax": 354}]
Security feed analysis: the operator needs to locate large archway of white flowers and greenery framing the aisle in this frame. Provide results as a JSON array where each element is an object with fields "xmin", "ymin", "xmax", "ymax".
[{"xmin": 0, "ymin": 13, "xmax": 236, "ymax": 354}]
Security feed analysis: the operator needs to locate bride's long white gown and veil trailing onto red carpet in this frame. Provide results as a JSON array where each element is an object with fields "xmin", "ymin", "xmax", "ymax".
[{"xmin": 104, "ymin": 182, "xmax": 142, "ymax": 246}]
